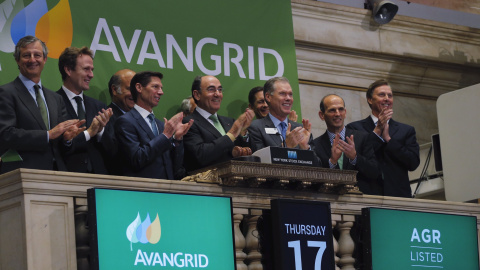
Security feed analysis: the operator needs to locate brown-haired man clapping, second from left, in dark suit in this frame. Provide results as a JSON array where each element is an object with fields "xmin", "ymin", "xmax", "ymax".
[{"xmin": 57, "ymin": 47, "xmax": 113, "ymax": 174}]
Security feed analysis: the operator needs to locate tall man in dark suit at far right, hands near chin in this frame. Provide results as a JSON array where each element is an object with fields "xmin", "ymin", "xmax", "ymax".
[{"xmin": 347, "ymin": 80, "xmax": 420, "ymax": 198}]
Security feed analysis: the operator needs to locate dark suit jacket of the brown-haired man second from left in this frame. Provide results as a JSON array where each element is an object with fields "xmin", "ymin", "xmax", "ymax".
[{"xmin": 57, "ymin": 88, "xmax": 112, "ymax": 174}]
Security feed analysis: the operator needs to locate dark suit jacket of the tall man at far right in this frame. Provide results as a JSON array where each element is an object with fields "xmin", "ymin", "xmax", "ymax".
[{"xmin": 347, "ymin": 116, "xmax": 420, "ymax": 198}]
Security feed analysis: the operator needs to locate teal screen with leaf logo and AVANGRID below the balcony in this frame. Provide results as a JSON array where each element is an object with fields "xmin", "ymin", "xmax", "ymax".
[{"xmin": 89, "ymin": 189, "xmax": 235, "ymax": 270}]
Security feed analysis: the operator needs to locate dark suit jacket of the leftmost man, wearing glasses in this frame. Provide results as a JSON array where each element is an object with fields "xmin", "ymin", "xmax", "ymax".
[{"xmin": 0, "ymin": 77, "xmax": 67, "ymax": 173}]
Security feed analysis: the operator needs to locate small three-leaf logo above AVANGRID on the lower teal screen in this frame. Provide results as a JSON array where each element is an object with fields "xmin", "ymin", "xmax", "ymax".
[{"xmin": 127, "ymin": 212, "xmax": 162, "ymax": 250}]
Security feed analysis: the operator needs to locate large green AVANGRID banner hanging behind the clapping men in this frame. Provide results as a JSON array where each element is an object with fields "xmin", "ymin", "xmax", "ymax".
[{"xmin": 0, "ymin": 0, "xmax": 301, "ymax": 117}]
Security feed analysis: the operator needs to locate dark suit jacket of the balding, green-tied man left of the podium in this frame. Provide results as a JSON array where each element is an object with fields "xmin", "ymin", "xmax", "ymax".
[{"xmin": 183, "ymin": 110, "xmax": 242, "ymax": 171}]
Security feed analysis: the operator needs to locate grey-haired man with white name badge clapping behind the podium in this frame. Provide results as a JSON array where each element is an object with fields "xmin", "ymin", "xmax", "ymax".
[{"xmin": 248, "ymin": 77, "xmax": 312, "ymax": 152}]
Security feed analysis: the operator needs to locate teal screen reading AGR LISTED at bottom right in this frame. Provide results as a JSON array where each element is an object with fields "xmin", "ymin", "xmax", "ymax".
[{"xmin": 364, "ymin": 208, "xmax": 478, "ymax": 270}]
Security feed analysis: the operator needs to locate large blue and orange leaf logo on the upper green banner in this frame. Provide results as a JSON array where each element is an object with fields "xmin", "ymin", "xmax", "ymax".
[{"xmin": 0, "ymin": 0, "xmax": 73, "ymax": 60}]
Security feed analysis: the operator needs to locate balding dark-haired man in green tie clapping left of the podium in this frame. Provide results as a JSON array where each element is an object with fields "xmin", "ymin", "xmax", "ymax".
[{"xmin": 184, "ymin": 76, "xmax": 253, "ymax": 171}]
